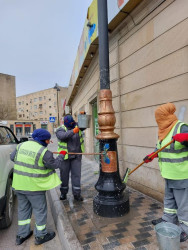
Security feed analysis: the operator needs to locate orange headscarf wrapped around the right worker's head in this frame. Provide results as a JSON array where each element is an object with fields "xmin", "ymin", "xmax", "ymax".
[{"xmin": 155, "ymin": 103, "xmax": 178, "ymax": 141}]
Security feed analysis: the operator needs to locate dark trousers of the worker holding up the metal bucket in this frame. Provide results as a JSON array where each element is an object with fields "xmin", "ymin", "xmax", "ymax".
[{"xmin": 60, "ymin": 157, "xmax": 81, "ymax": 195}]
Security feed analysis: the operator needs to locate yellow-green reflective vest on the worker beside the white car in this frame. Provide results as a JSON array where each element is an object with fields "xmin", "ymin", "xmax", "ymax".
[{"xmin": 12, "ymin": 141, "xmax": 61, "ymax": 191}]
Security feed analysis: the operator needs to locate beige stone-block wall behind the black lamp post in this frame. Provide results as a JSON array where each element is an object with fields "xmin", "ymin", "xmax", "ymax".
[{"xmin": 69, "ymin": 0, "xmax": 188, "ymax": 201}]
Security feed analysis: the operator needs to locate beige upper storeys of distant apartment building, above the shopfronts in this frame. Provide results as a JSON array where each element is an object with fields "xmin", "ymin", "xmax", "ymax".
[{"xmin": 16, "ymin": 87, "xmax": 67, "ymax": 127}]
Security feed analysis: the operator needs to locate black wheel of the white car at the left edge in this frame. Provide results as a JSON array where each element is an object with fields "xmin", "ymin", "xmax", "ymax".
[{"xmin": 0, "ymin": 178, "xmax": 14, "ymax": 229}]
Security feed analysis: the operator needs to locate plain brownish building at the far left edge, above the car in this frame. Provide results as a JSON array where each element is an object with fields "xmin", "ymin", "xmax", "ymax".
[{"xmin": 0, "ymin": 74, "xmax": 16, "ymax": 120}]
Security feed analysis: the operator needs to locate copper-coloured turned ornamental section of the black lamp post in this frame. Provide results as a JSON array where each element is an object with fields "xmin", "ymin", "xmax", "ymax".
[{"xmin": 96, "ymin": 89, "xmax": 119, "ymax": 140}]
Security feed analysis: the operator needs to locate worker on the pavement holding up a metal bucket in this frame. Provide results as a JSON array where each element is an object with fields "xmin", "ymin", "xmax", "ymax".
[{"xmin": 56, "ymin": 115, "xmax": 84, "ymax": 201}]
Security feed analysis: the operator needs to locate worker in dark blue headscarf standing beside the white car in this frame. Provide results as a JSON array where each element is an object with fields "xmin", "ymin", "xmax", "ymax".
[{"xmin": 10, "ymin": 129, "xmax": 64, "ymax": 245}]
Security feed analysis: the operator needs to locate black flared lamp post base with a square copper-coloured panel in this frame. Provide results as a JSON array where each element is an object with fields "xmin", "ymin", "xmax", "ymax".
[{"xmin": 93, "ymin": 139, "xmax": 129, "ymax": 218}]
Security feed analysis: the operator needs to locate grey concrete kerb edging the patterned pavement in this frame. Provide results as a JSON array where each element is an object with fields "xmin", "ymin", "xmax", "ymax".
[{"xmin": 47, "ymin": 189, "xmax": 83, "ymax": 250}]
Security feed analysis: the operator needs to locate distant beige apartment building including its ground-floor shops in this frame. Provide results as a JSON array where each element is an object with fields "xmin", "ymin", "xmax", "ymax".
[{"xmin": 16, "ymin": 86, "xmax": 67, "ymax": 134}]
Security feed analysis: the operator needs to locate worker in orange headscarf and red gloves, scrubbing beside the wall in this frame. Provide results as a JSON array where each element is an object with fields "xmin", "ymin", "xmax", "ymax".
[{"xmin": 144, "ymin": 103, "xmax": 188, "ymax": 242}]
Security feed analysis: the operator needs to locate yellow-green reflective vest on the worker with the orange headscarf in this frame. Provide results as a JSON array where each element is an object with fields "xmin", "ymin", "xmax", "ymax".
[{"xmin": 157, "ymin": 121, "xmax": 188, "ymax": 180}]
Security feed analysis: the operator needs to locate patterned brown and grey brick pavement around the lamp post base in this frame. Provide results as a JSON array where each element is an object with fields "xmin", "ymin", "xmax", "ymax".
[{"xmin": 57, "ymin": 156, "xmax": 188, "ymax": 250}]
